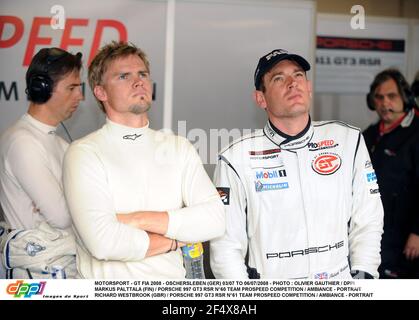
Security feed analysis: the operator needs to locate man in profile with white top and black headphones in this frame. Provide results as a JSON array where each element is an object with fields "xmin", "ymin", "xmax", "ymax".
[{"xmin": 0, "ymin": 48, "xmax": 83, "ymax": 278}]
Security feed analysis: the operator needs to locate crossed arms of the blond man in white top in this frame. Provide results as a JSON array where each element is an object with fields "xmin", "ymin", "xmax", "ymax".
[{"xmin": 63, "ymin": 136, "xmax": 224, "ymax": 261}]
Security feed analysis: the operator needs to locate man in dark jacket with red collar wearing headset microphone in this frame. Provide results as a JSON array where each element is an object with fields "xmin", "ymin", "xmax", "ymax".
[{"xmin": 364, "ymin": 69, "xmax": 419, "ymax": 278}]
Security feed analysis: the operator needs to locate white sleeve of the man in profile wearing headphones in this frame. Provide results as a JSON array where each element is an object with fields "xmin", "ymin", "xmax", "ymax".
[{"xmin": 7, "ymin": 135, "xmax": 71, "ymax": 229}]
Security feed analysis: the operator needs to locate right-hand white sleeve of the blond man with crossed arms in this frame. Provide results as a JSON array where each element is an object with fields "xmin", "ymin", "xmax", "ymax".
[{"xmin": 166, "ymin": 140, "xmax": 225, "ymax": 242}]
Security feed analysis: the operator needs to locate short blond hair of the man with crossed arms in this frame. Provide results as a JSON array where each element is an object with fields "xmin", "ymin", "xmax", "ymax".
[{"xmin": 88, "ymin": 41, "xmax": 150, "ymax": 112}]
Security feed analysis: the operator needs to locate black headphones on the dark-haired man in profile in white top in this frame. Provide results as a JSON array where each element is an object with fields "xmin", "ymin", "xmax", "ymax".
[{"xmin": 26, "ymin": 49, "xmax": 69, "ymax": 104}]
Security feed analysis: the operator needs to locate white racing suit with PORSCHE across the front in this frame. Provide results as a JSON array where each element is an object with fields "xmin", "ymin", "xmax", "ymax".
[{"xmin": 211, "ymin": 121, "xmax": 383, "ymax": 279}]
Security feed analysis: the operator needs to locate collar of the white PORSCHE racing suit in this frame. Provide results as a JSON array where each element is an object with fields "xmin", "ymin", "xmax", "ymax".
[{"xmin": 263, "ymin": 118, "xmax": 314, "ymax": 150}]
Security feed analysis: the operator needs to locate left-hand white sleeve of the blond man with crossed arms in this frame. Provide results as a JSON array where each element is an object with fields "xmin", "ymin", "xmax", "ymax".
[{"xmin": 63, "ymin": 144, "xmax": 150, "ymax": 261}]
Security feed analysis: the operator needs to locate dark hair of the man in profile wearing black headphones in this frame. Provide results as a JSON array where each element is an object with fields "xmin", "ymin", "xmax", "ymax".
[{"xmin": 26, "ymin": 48, "xmax": 82, "ymax": 101}]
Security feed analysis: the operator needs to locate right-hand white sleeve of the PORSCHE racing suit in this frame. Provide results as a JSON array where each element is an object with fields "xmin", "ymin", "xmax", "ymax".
[{"xmin": 349, "ymin": 134, "xmax": 384, "ymax": 278}]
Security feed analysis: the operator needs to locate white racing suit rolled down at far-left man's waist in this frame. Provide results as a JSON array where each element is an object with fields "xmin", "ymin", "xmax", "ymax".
[{"xmin": 0, "ymin": 222, "xmax": 79, "ymax": 279}]
